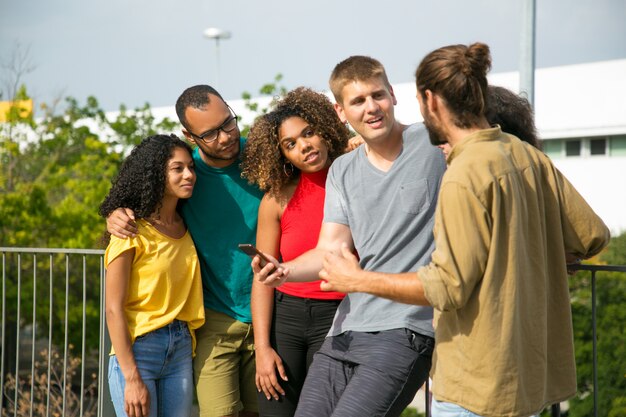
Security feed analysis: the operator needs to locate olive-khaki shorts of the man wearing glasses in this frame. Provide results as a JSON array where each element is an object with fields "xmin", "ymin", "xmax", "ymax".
[{"xmin": 193, "ymin": 308, "xmax": 258, "ymax": 417}]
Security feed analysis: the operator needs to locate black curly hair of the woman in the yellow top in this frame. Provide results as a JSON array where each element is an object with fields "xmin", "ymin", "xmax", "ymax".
[{"xmin": 98, "ymin": 135, "xmax": 192, "ymax": 219}]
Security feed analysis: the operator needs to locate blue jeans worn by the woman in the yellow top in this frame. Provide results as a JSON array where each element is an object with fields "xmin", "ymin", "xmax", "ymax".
[{"xmin": 109, "ymin": 320, "xmax": 194, "ymax": 417}]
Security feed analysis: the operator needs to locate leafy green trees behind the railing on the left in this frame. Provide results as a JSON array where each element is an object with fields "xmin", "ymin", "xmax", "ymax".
[{"xmin": 0, "ymin": 87, "xmax": 177, "ymax": 358}]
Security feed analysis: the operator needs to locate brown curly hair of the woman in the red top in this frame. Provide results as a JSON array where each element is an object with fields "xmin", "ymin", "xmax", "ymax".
[{"xmin": 241, "ymin": 87, "xmax": 350, "ymax": 197}]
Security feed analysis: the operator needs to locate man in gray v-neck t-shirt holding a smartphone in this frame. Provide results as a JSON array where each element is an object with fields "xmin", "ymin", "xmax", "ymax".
[{"xmin": 252, "ymin": 56, "xmax": 445, "ymax": 417}]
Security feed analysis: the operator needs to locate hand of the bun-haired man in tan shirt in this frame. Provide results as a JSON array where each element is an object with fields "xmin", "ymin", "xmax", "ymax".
[{"xmin": 319, "ymin": 243, "xmax": 363, "ymax": 293}]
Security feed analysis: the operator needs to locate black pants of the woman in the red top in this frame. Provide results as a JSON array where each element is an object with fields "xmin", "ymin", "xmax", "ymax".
[{"xmin": 258, "ymin": 291, "xmax": 340, "ymax": 417}]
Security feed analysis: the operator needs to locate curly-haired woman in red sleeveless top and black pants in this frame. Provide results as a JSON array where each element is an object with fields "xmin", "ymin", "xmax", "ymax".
[{"xmin": 242, "ymin": 87, "xmax": 350, "ymax": 416}]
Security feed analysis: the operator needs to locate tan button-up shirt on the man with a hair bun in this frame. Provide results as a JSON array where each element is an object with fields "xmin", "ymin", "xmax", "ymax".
[{"xmin": 418, "ymin": 127, "xmax": 609, "ymax": 417}]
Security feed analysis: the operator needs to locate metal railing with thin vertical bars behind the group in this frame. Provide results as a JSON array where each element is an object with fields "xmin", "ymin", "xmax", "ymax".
[{"xmin": 0, "ymin": 247, "xmax": 626, "ymax": 417}]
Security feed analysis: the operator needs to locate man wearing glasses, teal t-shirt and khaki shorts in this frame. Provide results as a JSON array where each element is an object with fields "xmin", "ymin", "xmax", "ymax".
[{"xmin": 107, "ymin": 85, "xmax": 262, "ymax": 417}]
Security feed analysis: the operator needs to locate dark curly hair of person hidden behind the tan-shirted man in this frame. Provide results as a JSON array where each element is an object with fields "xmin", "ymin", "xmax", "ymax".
[{"xmin": 485, "ymin": 85, "xmax": 541, "ymax": 149}]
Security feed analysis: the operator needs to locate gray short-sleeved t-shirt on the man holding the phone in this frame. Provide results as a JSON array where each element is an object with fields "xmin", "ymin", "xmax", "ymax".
[{"xmin": 324, "ymin": 123, "xmax": 446, "ymax": 336}]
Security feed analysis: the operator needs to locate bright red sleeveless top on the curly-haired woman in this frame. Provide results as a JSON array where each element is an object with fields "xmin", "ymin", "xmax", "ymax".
[{"xmin": 277, "ymin": 169, "xmax": 345, "ymax": 300}]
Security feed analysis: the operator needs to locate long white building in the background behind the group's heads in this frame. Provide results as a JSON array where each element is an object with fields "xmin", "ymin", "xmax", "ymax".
[{"xmin": 153, "ymin": 59, "xmax": 626, "ymax": 235}]
